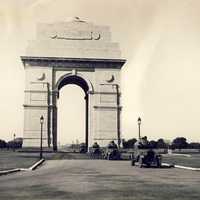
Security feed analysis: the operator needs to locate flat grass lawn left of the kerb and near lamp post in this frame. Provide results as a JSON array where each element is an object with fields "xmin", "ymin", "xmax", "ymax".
[{"xmin": 0, "ymin": 150, "xmax": 39, "ymax": 170}]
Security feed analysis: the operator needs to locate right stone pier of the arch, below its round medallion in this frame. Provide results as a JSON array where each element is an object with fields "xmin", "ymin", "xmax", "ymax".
[{"xmin": 93, "ymin": 83, "xmax": 121, "ymax": 146}]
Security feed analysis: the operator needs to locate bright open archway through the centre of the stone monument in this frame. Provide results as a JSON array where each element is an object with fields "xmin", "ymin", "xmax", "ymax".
[{"xmin": 57, "ymin": 84, "xmax": 85, "ymax": 150}]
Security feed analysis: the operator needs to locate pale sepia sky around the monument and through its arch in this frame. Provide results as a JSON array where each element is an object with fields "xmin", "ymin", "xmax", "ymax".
[{"xmin": 0, "ymin": 0, "xmax": 200, "ymax": 143}]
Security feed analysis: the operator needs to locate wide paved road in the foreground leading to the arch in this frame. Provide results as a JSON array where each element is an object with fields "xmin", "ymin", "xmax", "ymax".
[{"xmin": 0, "ymin": 160, "xmax": 200, "ymax": 200}]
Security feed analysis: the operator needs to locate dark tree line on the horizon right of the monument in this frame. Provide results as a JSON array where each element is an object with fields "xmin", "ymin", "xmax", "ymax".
[{"xmin": 122, "ymin": 137, "xmax": 200, "ymax": 149}]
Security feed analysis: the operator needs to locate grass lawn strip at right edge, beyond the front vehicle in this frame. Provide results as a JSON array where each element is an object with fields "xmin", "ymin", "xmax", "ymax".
[{"xmin": 163, "ymin": 154, "xmax": 200, "ymax": 168}]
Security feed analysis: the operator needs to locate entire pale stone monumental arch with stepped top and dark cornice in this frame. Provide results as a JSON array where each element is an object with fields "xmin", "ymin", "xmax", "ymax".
[{"xmin": 21, "ymin": 17, "xmax": 125, "ymax": 151}]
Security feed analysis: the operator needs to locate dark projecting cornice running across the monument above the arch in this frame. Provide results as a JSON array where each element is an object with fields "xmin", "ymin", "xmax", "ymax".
[{"xmin": 21, "ymin": 56, "xmax": 126, "ymax": 69}]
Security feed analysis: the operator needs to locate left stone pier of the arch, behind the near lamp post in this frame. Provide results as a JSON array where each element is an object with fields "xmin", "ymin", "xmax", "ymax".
[{"xmin": 23, "ymin": 82, "xmax": 49, "ymax": 147}]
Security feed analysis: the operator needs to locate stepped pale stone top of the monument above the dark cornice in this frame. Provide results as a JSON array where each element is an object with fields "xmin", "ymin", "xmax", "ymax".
[{"xmin": 27, "ymin": 17, "xmax": 121, "ymax": 59}]
